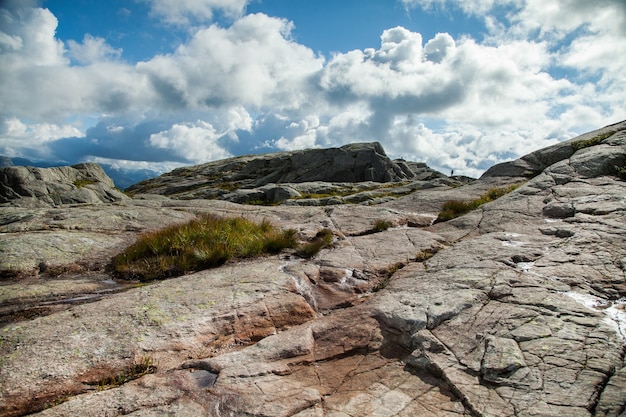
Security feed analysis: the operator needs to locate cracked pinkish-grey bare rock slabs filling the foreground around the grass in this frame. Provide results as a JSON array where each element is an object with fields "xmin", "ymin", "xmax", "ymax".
[{"xmin": 0, "ymin": 118, "xmax": 626, "ymax": 417}]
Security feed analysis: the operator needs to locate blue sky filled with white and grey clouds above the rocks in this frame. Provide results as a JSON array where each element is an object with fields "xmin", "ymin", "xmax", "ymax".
[{"xmin": 0, "ymin": 0, "xmax": 626, "ymax": 177}]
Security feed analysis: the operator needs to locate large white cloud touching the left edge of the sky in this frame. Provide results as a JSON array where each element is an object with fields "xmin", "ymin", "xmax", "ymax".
[{"xmin": 0, "ymin": 4, "xmax": 152, "ymax": 124}]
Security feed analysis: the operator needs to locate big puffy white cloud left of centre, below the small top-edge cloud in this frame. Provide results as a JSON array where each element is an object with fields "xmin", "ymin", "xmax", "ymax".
[{"xmin": 137, "ymin": 14, "xmax": 323, "ymax": 109}]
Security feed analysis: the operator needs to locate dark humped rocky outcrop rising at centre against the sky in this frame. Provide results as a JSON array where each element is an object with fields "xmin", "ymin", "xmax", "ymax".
[{"xmin": 127, "ymin": 142, "xmax": 454, "ymax": 203}]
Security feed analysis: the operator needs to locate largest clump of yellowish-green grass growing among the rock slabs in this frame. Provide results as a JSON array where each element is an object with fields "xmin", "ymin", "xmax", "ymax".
[{"xmin": 111, "ymin": 215, "xmax": 297, "ymax": 281}]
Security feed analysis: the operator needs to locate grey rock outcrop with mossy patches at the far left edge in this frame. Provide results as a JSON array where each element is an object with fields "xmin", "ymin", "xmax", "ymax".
[{"xmin": 0, "ymin": 163, "xmax": 127, "ymax": 206}]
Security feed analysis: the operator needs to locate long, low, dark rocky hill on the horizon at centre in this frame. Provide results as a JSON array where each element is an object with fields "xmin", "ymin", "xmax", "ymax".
[{"xmin": 123, "ymin": 142, "xmax": 466, "ymax": 205}]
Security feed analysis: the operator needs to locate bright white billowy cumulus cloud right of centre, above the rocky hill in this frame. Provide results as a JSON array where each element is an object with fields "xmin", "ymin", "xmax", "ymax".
[{"xmin": 320, "ymin": 27, "xmax": 463, "ymax": 110}]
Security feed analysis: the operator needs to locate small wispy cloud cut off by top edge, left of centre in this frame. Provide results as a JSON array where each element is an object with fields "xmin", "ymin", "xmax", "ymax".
[{"xmin": 143, "ymin": 0, "xmax": 249, "ymax": 26}]
